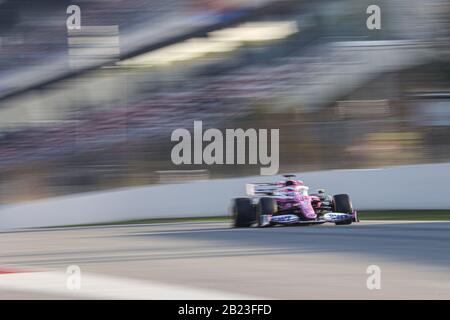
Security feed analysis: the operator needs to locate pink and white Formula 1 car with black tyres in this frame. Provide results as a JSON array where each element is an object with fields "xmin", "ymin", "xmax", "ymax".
[{"xmin": 231, "ymin": 175, "xmax": 359, "ymax": 228}]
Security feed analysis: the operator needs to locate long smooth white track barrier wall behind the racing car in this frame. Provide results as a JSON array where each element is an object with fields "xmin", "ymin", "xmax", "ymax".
[{"xmin": 0, "ymin": 163, "xmax": 450, "ymax": 230}]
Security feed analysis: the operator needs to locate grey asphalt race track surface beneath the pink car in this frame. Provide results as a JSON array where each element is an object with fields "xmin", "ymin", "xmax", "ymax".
[{"xmin": 0, "ymin": 221, "xmax": 450, "ymax": 299}]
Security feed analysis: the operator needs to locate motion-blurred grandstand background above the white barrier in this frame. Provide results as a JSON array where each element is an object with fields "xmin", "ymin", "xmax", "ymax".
[{"xmin": 0, "ymin": 0, "xmax": 450, "ymax": 203}]
